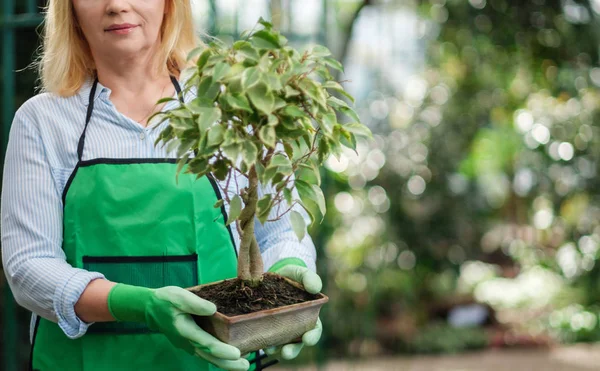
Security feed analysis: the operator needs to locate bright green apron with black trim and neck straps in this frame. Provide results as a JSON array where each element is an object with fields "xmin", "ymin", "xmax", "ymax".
[{"xmin": 31, "ymin": 77, "xmax": 237, "ymax": 371}]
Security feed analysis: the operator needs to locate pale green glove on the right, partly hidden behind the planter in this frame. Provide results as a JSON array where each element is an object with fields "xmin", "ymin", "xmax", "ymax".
[{"xmin": 265, "ymin": 258, "xmax": 323, "ymax": 360}]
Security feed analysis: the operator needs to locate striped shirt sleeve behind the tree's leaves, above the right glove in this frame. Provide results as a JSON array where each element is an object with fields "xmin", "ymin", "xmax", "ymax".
[{"xmin": 254, "ymin": 183, "xmax": 317, "ymax": 271}]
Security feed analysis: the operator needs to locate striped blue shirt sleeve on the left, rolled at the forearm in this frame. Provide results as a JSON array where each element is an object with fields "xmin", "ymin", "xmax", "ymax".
[{"xmin": 0, "ymin": 106, "xmax": 104, "ymax": 338}]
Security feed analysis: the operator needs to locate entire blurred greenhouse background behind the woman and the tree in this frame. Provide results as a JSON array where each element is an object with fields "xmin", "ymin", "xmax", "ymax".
[{"xmin": 0, "ymin": 0, "xmax": 600, "ymax": 371}]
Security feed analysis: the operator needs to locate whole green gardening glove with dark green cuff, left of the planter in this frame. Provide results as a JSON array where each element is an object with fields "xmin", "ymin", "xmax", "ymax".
[{"xmin": 108, "ymin": 283, "xmax": 250, "ymax": 371}]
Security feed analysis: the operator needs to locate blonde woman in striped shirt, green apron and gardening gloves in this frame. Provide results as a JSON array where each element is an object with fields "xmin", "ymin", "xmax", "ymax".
[{"xmin": 2, "ymin": 0, "xmax": 321, "ymax": 371}]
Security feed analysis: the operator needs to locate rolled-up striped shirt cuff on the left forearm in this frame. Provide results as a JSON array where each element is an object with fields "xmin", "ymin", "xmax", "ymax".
[{"xmin": 54, "ymin": 269, "xmax": 104, "ymax": 339}]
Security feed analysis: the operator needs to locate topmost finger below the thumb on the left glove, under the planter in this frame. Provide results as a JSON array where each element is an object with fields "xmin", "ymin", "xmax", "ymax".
[{"xmin": 175, "ymin": 314, "xmax": 241, "ymax": 360}]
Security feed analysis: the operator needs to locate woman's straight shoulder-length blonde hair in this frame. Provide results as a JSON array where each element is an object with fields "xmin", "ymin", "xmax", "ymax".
[{"xmin": 36, "ymin": 0, "xmax": 200, "ymax": 96}]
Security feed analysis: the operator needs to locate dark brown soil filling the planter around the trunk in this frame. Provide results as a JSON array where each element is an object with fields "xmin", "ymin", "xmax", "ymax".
[{"xmin": 192, "ymin": 274, "xmax": 320, "ymax": 316}]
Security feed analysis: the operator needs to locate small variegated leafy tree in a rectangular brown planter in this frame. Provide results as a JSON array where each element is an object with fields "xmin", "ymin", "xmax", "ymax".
[{"xmin": 156, "ymin": 18, "xmax": 370, "ymax": 353}]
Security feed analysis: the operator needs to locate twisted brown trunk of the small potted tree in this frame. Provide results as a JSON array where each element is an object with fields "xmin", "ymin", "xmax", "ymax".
[{"xmin": 238, "ymin": 166, "xmax": 263, "ymax": 287}]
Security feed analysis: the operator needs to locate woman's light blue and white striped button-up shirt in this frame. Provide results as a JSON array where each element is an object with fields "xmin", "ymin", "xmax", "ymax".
[{"xmin": 1, "ymin": 80, "xmax": 316, "ymax": 338}]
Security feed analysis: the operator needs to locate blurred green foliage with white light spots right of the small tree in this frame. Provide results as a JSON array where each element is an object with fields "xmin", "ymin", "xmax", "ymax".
[{"xmin": 326, "ymin": 0, "xmax": 600, "ymax": 360}]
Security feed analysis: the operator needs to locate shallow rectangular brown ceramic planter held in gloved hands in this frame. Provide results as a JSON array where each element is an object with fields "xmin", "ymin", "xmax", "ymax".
[{"xmin": 188, "ymin": 273, "xmax": 329, "ymax": 354}]
